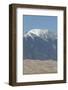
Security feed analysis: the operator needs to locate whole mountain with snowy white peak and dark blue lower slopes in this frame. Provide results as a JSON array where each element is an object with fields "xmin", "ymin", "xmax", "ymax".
[{"xmin": 23, "ymin": 29, "xmax": 57, "ymax": 60}]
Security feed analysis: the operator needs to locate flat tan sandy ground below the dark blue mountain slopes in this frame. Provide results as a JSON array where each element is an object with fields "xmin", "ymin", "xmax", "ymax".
[{"xmin": 23, "ymin": 59, "xmax": 57, "ymax": 75}]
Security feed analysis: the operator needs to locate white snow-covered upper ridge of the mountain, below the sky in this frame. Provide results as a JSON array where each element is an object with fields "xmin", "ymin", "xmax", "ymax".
[{"xmin": 24, "ymin": 29, "xmax": 57, "ymax": 40}]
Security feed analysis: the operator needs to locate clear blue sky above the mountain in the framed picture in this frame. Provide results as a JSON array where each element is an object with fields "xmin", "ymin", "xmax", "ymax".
[{"xmin": 23, "ymin": 15, "xmax": 57, "ymax": 32}]
